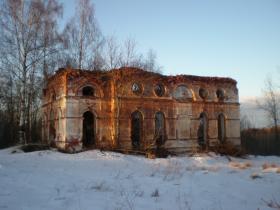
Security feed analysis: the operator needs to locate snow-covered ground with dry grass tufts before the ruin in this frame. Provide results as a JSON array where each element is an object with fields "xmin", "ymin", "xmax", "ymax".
[{"xmin": 0, "ymin": 148, "xmax": 280, "ymax": 210}]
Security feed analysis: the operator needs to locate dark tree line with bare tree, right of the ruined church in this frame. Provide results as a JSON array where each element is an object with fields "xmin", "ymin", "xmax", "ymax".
[{"xmin": 240, "ymin": 76, "xmax": 280, "ymax": 155}]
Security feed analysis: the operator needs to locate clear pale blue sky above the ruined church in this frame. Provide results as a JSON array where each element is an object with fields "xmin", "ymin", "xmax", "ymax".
[{"xmin": 60, "ymin": 0, "xmax": 280, "ymax": 101}]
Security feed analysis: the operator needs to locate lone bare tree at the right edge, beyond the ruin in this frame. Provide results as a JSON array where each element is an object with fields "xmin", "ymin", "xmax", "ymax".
[{"xmin": 257, "ymin": 77, "xmax": 280, "ymax": 139}]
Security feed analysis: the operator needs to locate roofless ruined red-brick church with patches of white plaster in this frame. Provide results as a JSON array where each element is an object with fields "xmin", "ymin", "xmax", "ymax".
[{"xmin": 42, "ymin": 68, "xmax": 240, "ymax": 153}]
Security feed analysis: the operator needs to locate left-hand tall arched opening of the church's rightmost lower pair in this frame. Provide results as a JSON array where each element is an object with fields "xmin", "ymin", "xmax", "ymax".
[{"xmin": 197, "ymin": 113, "xmax": 208, "ymax": 148}]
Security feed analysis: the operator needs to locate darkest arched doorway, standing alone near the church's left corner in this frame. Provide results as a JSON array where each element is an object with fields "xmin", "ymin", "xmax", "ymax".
[{"xmin": 82, "ymin": 111, "xmax": 95, "ymax": 147}]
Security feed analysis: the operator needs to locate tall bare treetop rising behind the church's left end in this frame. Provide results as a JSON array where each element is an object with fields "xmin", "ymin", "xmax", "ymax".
[{"xmin": 63, "ymin": 0, "xmax": 102, "ymax": 69}]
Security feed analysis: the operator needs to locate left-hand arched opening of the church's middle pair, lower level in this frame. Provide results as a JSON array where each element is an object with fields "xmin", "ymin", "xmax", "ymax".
[{"xmin": 131, "ymin": 111, "xmax": 143, "ymax": 149}]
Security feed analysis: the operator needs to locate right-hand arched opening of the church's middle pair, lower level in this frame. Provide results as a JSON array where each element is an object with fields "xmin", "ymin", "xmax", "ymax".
[{"xmin": 155, "ymin": 112, "xmax": 165, "ymax": 148}]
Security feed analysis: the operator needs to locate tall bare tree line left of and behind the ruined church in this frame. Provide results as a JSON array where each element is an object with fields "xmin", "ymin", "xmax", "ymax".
[{"xmin": 0, "ymin": 0, "xmax": 161, "ymax": 148}]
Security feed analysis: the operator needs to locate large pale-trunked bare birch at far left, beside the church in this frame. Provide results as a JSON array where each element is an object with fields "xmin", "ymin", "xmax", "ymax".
[{"xmin": 0, "ymin": 0, "xmax": 60, "ymax": 142}]
